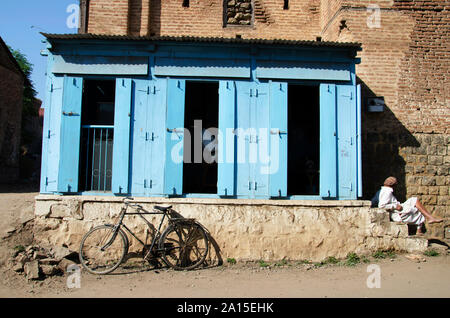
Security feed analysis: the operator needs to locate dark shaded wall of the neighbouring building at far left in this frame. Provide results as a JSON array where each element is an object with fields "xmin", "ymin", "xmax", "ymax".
[{"xmin": 0, "ymin": 46, "xmax": 23, "ymax": 183}]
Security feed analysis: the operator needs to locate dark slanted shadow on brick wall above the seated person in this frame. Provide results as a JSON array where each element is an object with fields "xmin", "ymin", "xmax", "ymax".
[{"xmin": 357, "ymin": 78, "xmax": 420, "ymax": 201}]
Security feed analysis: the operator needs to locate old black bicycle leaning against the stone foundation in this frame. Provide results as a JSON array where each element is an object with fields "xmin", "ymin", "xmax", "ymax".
[{"xmin": 79, "ymin": 198, "xmax": 209, "ymax": 275}]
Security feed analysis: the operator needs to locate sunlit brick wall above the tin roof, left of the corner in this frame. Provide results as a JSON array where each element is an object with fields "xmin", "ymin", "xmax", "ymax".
[{"xmin": 84, "ymin": 0, "xmax": 320, "ymax": 40}]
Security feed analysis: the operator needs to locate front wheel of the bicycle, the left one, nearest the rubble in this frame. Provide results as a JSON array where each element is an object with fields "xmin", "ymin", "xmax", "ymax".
[{"xmin": 79, "ymin": 225, "xmax": 128, "ymax": 275}]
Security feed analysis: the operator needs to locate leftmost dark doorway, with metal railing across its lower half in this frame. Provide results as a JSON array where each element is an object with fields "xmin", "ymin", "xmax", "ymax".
[{"xmin": 79, "ymin": 80, "xmax": 116, "ymax": 192}]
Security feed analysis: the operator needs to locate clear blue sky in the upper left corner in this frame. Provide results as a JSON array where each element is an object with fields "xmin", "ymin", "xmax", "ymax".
[{"xmin": 0, "ymin": 0, "xmax": 78, "ymax": 100}]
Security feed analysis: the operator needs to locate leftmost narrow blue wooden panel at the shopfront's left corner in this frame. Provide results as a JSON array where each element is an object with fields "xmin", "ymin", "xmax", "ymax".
[{"xmin": 40, "ymin": 76, "xmax": 64, "ymax": 193}]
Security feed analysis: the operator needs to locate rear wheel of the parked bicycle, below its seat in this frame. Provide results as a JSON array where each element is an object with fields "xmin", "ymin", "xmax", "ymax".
[{"xmin": 159, "ymin": 221, "xmax": 208, "ymax": 270}]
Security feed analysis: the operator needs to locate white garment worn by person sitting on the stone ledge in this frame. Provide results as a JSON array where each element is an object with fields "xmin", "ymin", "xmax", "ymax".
[{"xmin": 378, "ymin": 186, "xmax": 425, "ymax": 225}]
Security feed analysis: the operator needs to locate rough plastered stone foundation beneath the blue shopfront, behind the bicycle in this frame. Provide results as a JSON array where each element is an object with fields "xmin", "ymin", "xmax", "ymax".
[{"xmin": 35, "ymin": 195, "xmax": 428, "ymax": 261}]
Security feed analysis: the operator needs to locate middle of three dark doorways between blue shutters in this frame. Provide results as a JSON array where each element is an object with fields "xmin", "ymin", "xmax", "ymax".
[{"xmin": 183, "ymin": 81, "xmax": 219, "ymax": 194}]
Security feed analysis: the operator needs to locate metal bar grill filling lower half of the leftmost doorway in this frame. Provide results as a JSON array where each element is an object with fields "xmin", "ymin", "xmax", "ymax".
[{"xmin": 80, "ymin": 125, "xmax": 114, "ymax": 192}]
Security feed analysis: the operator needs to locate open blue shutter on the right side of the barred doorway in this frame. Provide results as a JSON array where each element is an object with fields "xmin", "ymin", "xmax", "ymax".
[{"xmin": 112, "ymin": 78, "xmax": 132, "ymax": 194}]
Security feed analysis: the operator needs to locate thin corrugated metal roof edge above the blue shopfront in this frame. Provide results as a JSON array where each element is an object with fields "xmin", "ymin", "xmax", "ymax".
[{"xmin": 41, "ymin": 32, "xmax": 362, "ymax": 50}]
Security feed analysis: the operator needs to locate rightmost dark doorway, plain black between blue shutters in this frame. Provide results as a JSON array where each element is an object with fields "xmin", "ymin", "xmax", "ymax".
[{"xmin": 288, "ymin": 84, "xmax": 320, "ymax": 195}]
